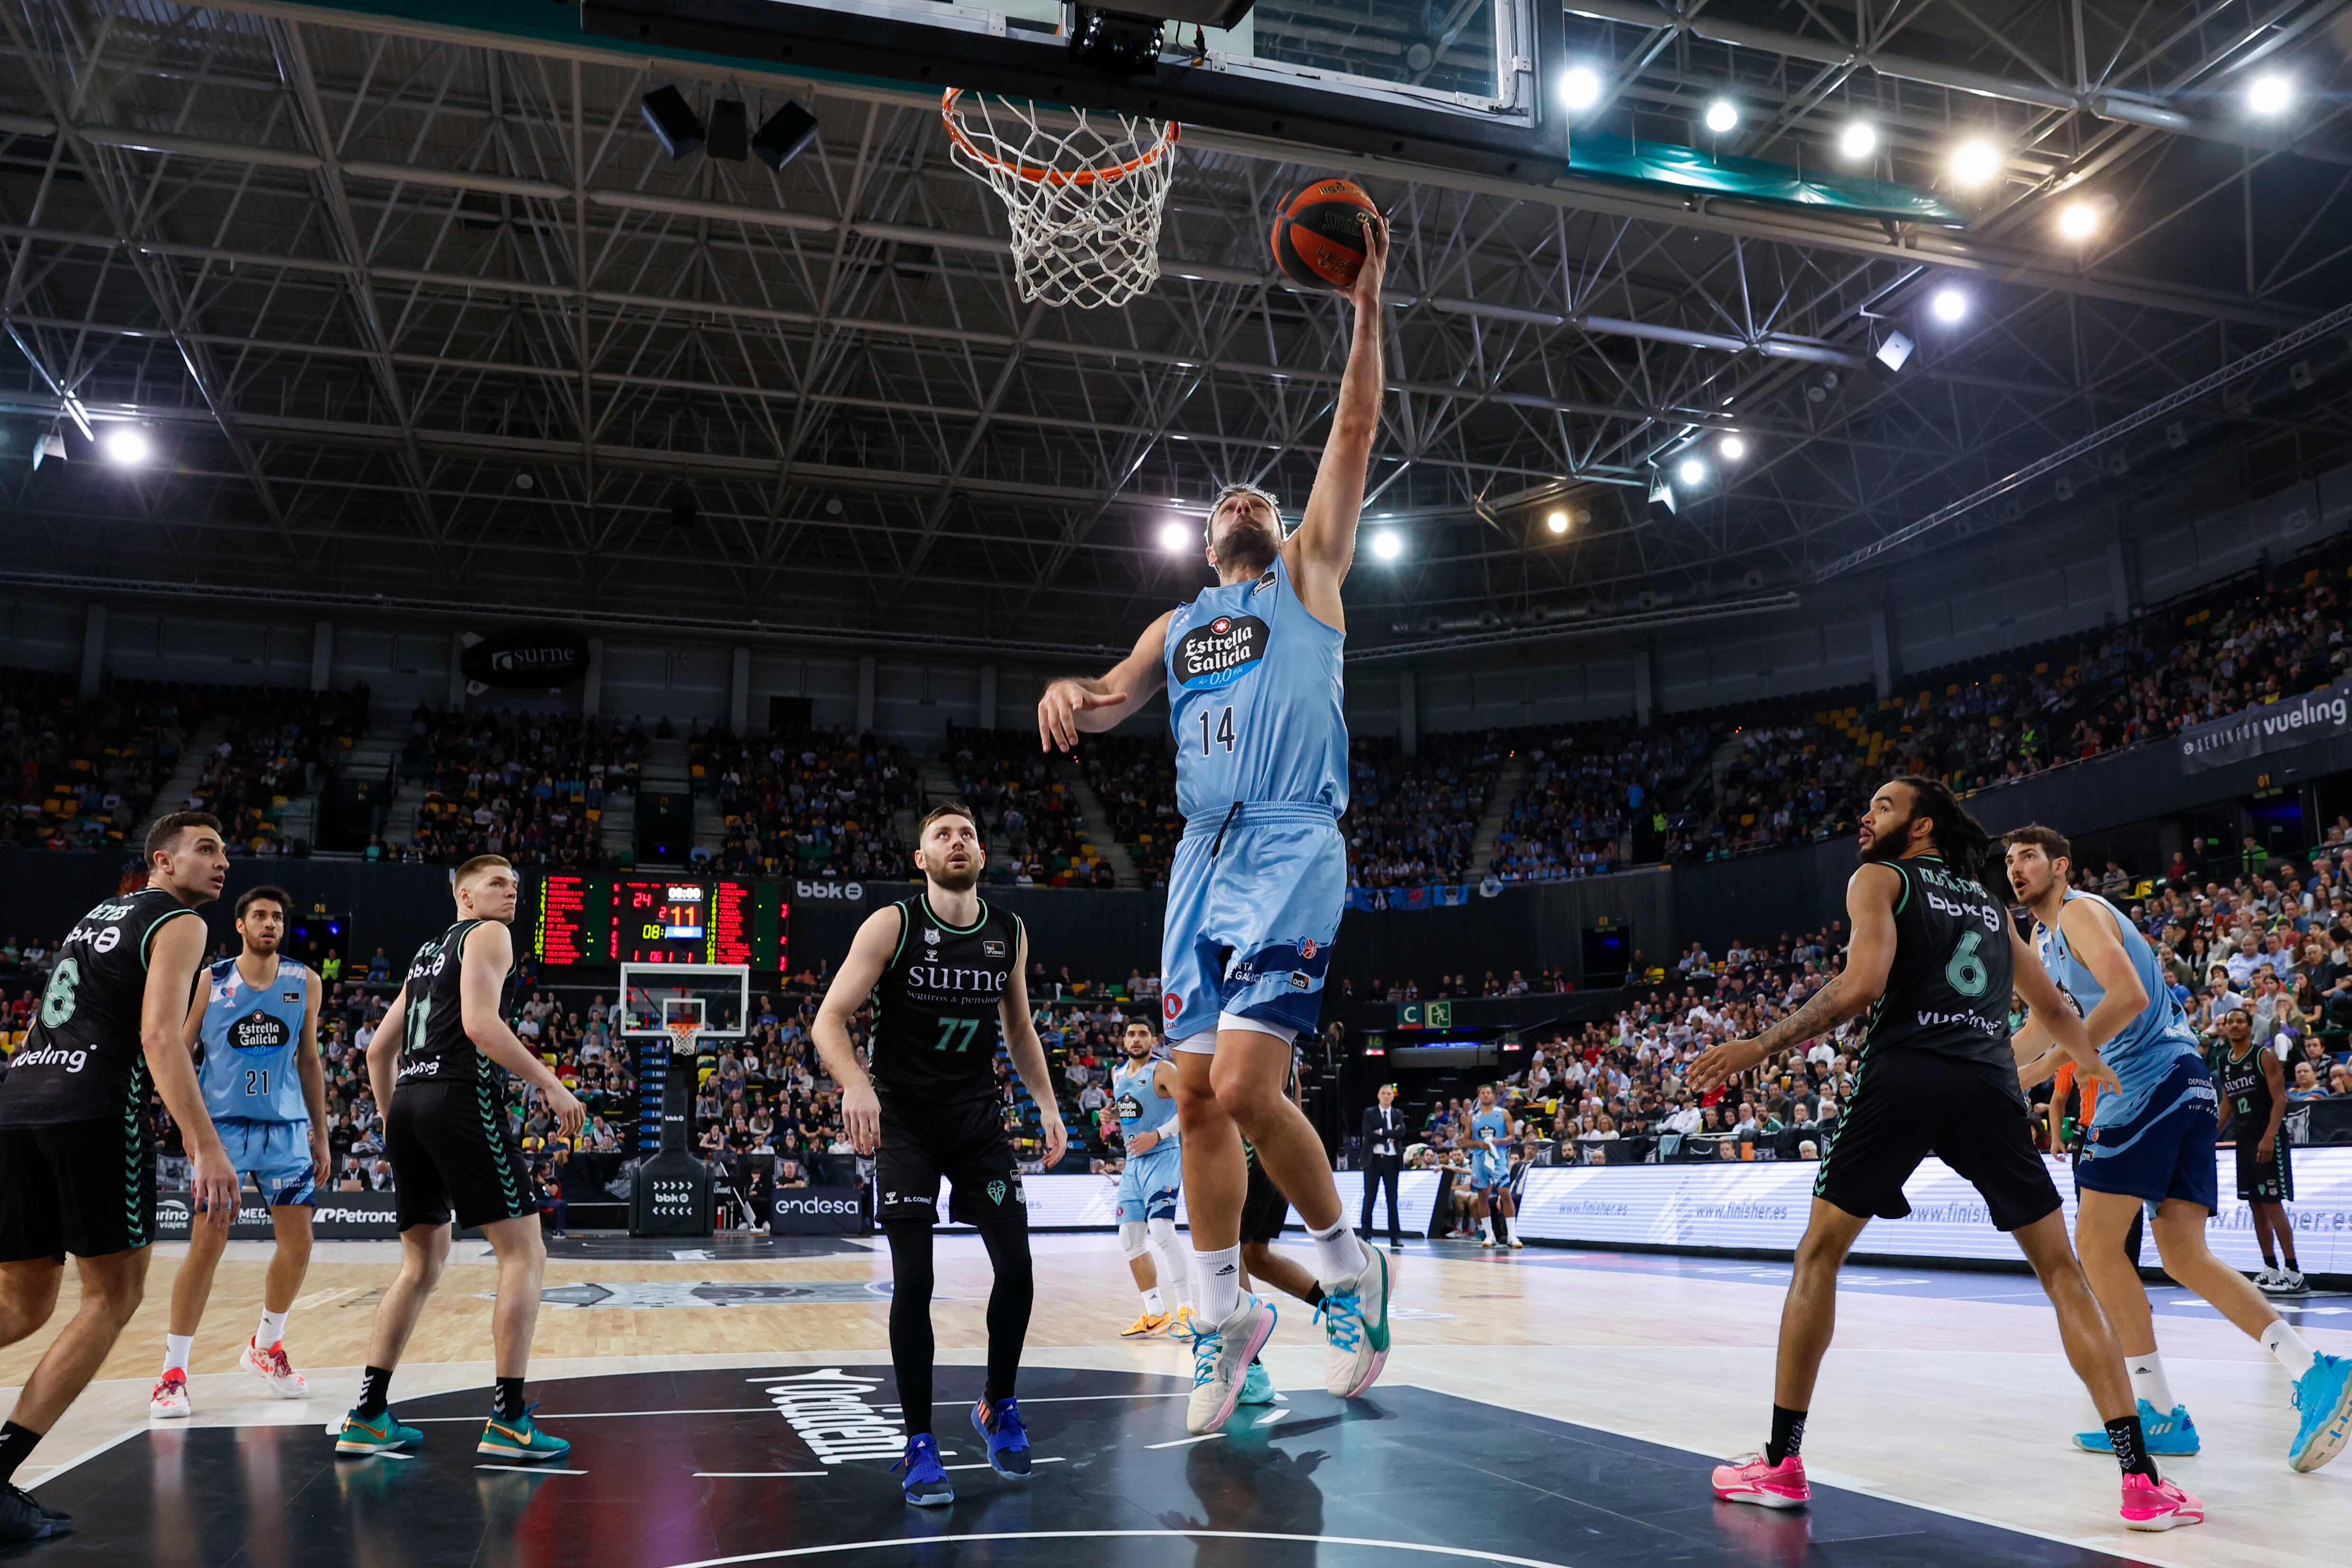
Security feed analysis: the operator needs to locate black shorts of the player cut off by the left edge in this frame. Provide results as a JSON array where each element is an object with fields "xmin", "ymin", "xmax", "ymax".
[{"xmin": 0, "ymin": 1117, "xmax": 155, "ymax": 1262}]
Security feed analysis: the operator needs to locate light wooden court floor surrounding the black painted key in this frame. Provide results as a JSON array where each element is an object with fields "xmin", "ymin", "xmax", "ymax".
[{"xmin": 0, "ymin": 1234, "xmax": 2352, "ymax": 1568}]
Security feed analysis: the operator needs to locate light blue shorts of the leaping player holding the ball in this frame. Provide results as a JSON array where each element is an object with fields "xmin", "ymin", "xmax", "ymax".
[{"xmin": 1159, "ymin": 804, "xmax": 1348, "ymax": 1051}]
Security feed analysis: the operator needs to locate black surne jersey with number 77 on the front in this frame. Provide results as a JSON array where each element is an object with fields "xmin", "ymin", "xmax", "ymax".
[{"xmin": 868, "ymin": 893, "xmax": 1021, "ymax": 1102}]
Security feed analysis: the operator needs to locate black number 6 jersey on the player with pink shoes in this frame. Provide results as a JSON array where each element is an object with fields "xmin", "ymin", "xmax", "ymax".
[{"xmin": 1863, "ymin": 856, "xmax": 2018, "ymax": 1088}]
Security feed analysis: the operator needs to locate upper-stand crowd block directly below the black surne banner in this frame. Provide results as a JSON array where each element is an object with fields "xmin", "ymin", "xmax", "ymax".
[{"xmin": 400, "ymin": 703, "xmax": 649, "ymax": 870}]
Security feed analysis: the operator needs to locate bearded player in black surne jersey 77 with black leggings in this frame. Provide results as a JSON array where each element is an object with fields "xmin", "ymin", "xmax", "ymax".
[{"xmin": 814, "ymin": 804, "xmax": 1070, "ymax": 1507}]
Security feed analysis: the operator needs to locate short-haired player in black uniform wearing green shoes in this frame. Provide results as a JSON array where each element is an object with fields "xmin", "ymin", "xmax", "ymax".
[{"xmin": 334, "ymin": 856, "xmax": 588, "ymax": 1465}]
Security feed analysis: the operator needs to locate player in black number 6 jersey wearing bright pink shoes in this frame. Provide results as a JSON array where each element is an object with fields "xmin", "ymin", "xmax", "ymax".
[{"xmin": 1686, "ymin": 776, "xmax": 2204, "ymax": 1531}]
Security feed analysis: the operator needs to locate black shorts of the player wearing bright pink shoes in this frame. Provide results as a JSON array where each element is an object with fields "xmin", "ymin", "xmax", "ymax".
[{"xmin": 1813, "ymin": 1051, "xmax": 2058, "ymax": 1232}]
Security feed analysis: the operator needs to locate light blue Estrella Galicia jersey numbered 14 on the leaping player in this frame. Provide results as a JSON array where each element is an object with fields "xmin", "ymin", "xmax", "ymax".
[{"xmin": 1167, "ymin": 555, "xmax": 1348, "ymax": 825}]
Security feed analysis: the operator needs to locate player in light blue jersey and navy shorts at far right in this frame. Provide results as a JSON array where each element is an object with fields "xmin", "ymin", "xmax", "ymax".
[{"xmin": 2002, "ymin": 825, "xmax": 2352, "ymax": 1469}]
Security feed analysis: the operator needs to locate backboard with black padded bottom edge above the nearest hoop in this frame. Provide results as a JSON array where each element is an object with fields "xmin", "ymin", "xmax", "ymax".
[{"xmin": 581, "ymin": 0, "xmax": 1569, "ymax": 183}]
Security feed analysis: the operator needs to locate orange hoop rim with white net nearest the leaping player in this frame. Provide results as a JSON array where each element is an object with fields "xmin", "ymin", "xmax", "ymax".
[{"xmin": 938, "ymin": 87, "xmax": 1178, "ymax": 310}]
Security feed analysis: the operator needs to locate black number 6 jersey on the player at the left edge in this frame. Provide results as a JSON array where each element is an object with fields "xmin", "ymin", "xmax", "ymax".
[{"xmin": 0, "ymin": 888, "xmax": 202, "ymax": 1126}]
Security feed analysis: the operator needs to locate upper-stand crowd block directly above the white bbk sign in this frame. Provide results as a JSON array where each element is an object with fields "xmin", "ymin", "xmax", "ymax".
[{"xmin": 687, "ymin": 727, "xmax": 922, "ymax": 879}]
